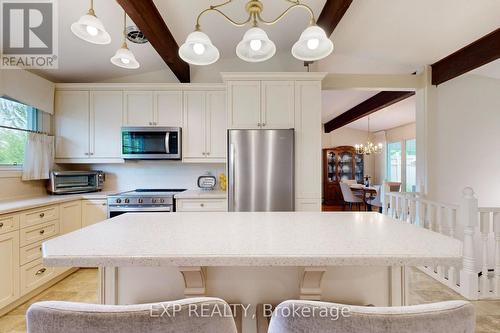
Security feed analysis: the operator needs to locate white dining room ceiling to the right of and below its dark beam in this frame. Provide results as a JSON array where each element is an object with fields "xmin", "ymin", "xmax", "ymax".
[{"xmin": 346, "ymin": 96, "xmax": 416, "ymax": 132}]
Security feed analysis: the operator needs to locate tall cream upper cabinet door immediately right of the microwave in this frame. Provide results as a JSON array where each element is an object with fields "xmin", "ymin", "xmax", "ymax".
[{"xmin": 182, "ymin": 91, "xmax": 207, "ymax": 159}]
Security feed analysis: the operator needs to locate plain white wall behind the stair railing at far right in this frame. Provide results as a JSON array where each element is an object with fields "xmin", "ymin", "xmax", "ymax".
[{"xmin": 427, "ymin": 75, "xmax": 500, "ymax": 206}]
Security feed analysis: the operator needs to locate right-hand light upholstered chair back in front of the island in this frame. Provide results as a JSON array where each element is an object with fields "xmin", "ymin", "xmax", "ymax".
[{"xmin": 268, "ymin": 301, "xmax": 475, "ymax": 333}]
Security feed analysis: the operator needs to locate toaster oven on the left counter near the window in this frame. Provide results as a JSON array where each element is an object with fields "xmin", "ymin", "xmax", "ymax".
[{"xmin": 47, "ymin": 171, "xmax": 105, "ymax": 194}]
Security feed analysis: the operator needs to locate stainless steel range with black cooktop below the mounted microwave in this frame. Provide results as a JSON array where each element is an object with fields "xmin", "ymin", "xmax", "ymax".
[{"xmin": 108, "ymin": 189, "xmax": 185, "ymax": 218}]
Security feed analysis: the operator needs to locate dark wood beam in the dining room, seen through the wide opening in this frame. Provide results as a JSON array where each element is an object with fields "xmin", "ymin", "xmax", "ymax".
[{"xmin": 325, "ymin": 91, "xmax": 415, "ymax": 133}]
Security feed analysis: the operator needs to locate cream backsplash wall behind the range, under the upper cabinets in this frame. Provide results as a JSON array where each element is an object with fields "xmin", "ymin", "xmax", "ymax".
[{"xmin": 63, "ymin": 161, "xmax": 225, "ymax": 191}]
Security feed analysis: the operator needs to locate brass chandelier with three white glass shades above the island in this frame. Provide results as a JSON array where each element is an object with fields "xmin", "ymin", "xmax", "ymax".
[{"xmin": 179, "ymin": 0, "xmax": 333, "ymax": 66}]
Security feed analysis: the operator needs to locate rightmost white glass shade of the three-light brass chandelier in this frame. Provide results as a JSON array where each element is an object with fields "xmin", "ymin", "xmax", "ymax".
[{"xmin": 292, "ymin": 25, "xmax": 333, "ymax": 61}]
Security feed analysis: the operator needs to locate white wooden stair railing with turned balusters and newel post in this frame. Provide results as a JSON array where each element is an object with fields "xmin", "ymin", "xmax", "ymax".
[{"xmin": 383, "ymin": 187, "xmax": 500, "ymax": 300}]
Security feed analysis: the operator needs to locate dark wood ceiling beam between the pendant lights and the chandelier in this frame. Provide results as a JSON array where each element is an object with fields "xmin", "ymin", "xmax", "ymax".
[{"xmin": 117, "ymin": 0, "xmax": 190, "ymax": 83}]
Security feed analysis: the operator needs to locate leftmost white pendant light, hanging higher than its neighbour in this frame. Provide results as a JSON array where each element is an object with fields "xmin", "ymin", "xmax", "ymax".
[{"xmin": 71, "ymin": 0, "xmax": 111, "ymax": 44}]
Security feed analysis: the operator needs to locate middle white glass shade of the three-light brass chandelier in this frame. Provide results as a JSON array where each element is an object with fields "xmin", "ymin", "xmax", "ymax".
[{"xmin": 236, "ymin": 28, "xmax": 276, "ymax": 62}]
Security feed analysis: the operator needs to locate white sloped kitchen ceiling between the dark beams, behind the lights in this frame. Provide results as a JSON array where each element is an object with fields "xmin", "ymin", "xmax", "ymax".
[{"xmin": 33, "ymin": 0, "xmax": 500, "ymax": 82}]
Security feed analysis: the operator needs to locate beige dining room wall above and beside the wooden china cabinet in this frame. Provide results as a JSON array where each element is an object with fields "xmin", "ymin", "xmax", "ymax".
[{"xmin": 321, "ymin": 126, "xmax": 378, "ymax": 183}]
